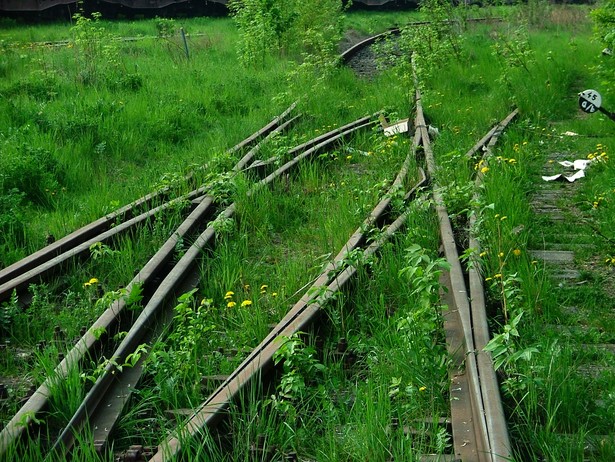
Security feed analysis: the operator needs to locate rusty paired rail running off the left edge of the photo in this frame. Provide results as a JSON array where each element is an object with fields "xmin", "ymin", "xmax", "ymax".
[{"xmin": 0, "ymin": 103, "xmax": 296, "ymax": 302}]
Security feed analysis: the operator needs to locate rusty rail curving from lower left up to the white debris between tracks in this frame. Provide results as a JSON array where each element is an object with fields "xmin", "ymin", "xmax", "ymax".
[{"xmin": 45, "ymin": 114, "xmax": 376, "ymax": 455}]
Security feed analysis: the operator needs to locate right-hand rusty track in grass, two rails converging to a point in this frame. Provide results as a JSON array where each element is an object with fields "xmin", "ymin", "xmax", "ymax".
[{"xmin": 148, "ymin": 88, "xmax": 516, "ymax": 461}]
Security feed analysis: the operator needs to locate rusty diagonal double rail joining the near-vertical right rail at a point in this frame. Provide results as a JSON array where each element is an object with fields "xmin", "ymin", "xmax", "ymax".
[{"xmin": 150, "ymin": 127, "xmax": 427, "ymax": 462}]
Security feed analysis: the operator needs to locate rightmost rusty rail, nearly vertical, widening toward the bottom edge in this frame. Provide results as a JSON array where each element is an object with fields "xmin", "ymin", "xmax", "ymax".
[{"xmin": 415, "ymin": 67, "xmax": 516, "ymax": 462}]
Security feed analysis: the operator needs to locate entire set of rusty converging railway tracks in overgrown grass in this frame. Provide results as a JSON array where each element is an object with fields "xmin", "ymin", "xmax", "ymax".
[{"xmin": 0, "ymin": 30, "xmax": 516, "ymax": 461}]
